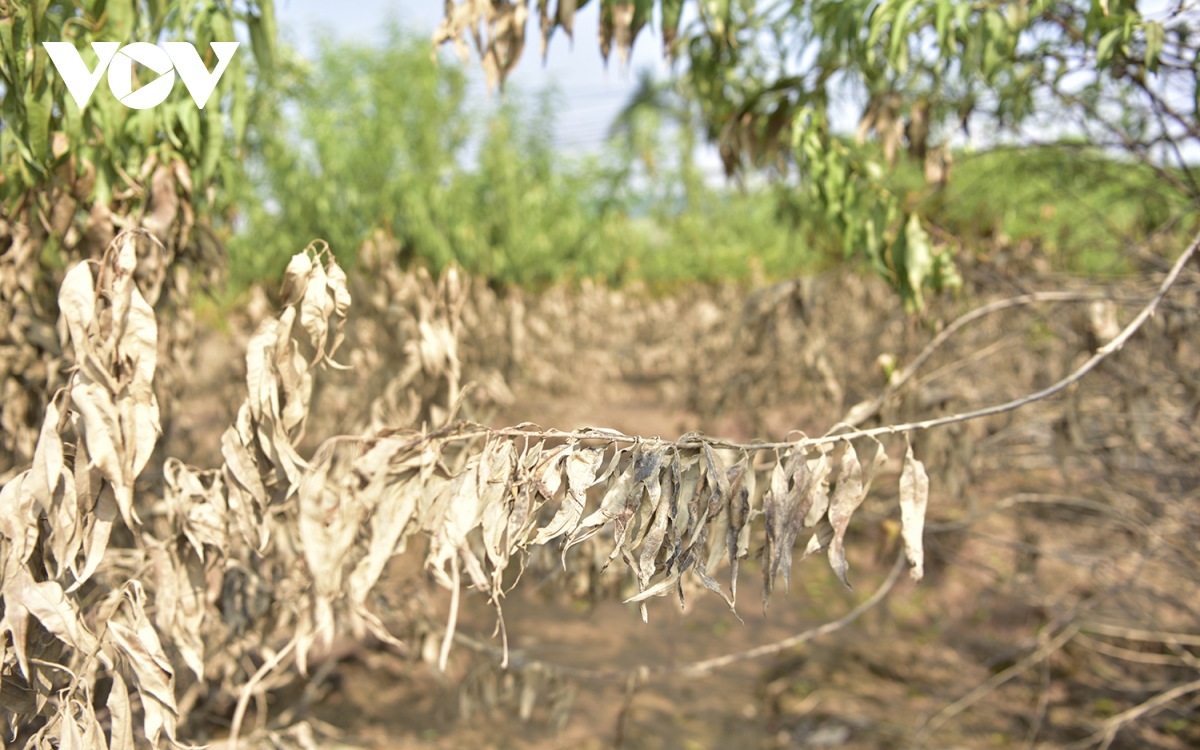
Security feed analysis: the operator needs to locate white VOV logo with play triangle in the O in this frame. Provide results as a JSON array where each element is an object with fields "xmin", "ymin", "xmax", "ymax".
[{"xmin": 42, "ymin": 42, "xmax": 238, "ymax": 109}]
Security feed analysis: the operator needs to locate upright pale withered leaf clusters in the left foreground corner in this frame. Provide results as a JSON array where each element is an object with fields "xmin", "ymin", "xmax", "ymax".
[{"xmin": 0, "ymin": 233, "xmax": 349, "ymax": 749}]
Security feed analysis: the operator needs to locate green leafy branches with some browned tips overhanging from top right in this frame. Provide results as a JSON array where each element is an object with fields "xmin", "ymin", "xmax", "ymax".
[{"xmin": 434, "ymin": 0, "xmax": 1200, "ymax": 304}]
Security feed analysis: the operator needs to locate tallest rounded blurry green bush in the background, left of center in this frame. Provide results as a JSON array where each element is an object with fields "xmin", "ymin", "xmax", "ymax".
[{"xmin": 229, "ymin": 29, "xmax": 470, "ymax": 282}]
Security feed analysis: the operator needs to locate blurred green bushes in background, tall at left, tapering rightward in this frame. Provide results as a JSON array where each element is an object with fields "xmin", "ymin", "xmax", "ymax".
[{"xmin": 229, "ymin": 28, "xmax": 812, "ymax": 286}]
